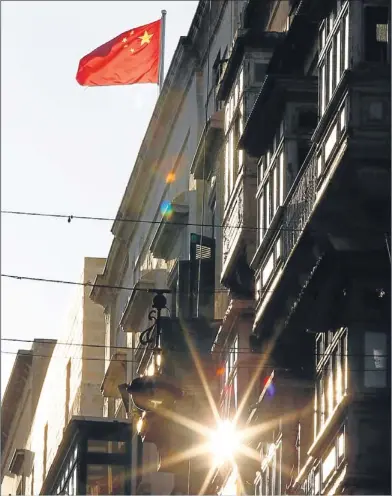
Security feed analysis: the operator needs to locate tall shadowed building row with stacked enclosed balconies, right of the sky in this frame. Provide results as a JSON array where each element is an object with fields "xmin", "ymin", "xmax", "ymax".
[{"xmin": 91, "ymin": 0, "xmax": 391, "ymax": 495}]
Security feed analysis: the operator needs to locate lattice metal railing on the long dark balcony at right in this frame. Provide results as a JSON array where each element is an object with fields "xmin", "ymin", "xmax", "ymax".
[{"xmin": 282, "ymin": 148, "xmax": 317, "ymax": 262}]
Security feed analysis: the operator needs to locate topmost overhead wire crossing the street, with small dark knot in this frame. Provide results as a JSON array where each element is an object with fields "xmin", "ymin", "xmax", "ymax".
[{"xmin": 1, "ymin": 210, "xmax": 389, "ymax": 235}]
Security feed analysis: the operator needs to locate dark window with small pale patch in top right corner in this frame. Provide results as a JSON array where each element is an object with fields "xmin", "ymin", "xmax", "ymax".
[{"xmin": 365, "ymin": 7, "xmax": 388, "ymax": 62}]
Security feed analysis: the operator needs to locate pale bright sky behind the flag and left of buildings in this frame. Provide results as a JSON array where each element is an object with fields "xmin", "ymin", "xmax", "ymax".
[{"xmin": 1, "ymin": 0, "xmax": 197, "ymax": 392}]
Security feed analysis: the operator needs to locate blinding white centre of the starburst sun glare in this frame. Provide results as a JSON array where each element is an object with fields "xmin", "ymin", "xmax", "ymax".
[{"xmin": 209, "ymin": 420, "xmax": 240, "ymax": 466}]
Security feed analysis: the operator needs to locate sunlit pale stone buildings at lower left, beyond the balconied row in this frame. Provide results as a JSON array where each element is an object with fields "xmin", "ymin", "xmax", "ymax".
[{"xmin": 1, "ymin": 258, "xmax": 105, "ymax": 495}]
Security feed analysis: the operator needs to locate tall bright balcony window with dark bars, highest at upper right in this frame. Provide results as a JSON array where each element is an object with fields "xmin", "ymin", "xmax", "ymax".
[{"xmin": 318, "ymin": 2, "xmax": 349, "ymax": 115}]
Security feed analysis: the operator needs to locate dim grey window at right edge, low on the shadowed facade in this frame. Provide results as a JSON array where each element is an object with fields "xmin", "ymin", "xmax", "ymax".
[{"xmin": 364, "ymin": 332, "xmax": 387, "ymax": 388}]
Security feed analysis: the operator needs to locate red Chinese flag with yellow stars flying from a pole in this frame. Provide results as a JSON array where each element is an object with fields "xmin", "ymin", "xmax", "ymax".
[{"xmin": 76, "ymin": 20, "xmax": 161, "ymax": 86}]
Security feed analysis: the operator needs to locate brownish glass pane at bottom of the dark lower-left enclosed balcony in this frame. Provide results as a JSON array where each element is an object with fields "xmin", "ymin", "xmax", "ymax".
[{"xmin": 86, "ymin": 465, "xmax": 126, "ymax": 495}]
